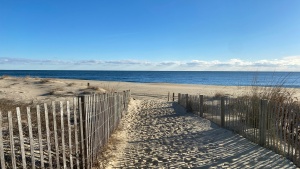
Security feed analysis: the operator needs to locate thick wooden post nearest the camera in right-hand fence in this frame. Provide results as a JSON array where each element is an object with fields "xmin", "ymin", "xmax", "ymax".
[{"xmin": 259, "ymin": 99, "xmax": 268, "ymax": 146}]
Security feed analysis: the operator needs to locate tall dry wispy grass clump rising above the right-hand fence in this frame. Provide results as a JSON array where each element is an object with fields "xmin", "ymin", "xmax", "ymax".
[{"xmin": 235, "ymin": 74, "xmax": 300, "ymax": 133}]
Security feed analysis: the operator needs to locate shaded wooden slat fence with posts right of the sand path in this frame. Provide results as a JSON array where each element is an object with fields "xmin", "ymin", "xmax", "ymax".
[{"xmin": 178, "ymin": 93, "xmax": 300, "ymax": 167}]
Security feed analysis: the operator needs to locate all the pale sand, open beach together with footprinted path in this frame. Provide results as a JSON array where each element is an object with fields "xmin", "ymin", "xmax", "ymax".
[{"xmin": 0, "ymin": 77, "xmax": 300, "ymax": 168}]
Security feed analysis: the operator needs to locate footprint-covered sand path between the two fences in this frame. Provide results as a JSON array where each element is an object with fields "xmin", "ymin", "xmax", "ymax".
[{"xmin": 107, "ymin": 100, "xmax": 296, "ymax": 168}]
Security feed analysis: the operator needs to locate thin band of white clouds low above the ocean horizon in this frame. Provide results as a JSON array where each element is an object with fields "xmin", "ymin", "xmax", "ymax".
[{"xmin": 0, "ymin": 56, "xmax": 300, "ymax": 71}]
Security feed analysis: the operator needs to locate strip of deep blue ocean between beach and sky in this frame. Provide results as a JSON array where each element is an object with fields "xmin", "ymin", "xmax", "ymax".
[{"xmin": 0, "ymin": 70, "xmax": 300, "ymax": 88}]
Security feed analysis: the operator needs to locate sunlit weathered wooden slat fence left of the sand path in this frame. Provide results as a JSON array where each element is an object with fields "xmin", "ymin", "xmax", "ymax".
[{"xmin": 0, "ymin": 91, "xmax": 130, "ymax": 169}]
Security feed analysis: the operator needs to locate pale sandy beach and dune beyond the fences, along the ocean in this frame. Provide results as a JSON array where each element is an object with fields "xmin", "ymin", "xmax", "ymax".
[{"xmin": 0, "ymin": 76, "xmax": 300, "ymax": 103}]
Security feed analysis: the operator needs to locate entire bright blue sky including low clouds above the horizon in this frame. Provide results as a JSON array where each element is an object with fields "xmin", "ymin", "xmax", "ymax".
[{"xmin": 0, "ymin": 0, "xmax": 300, "ymax": 71}]
